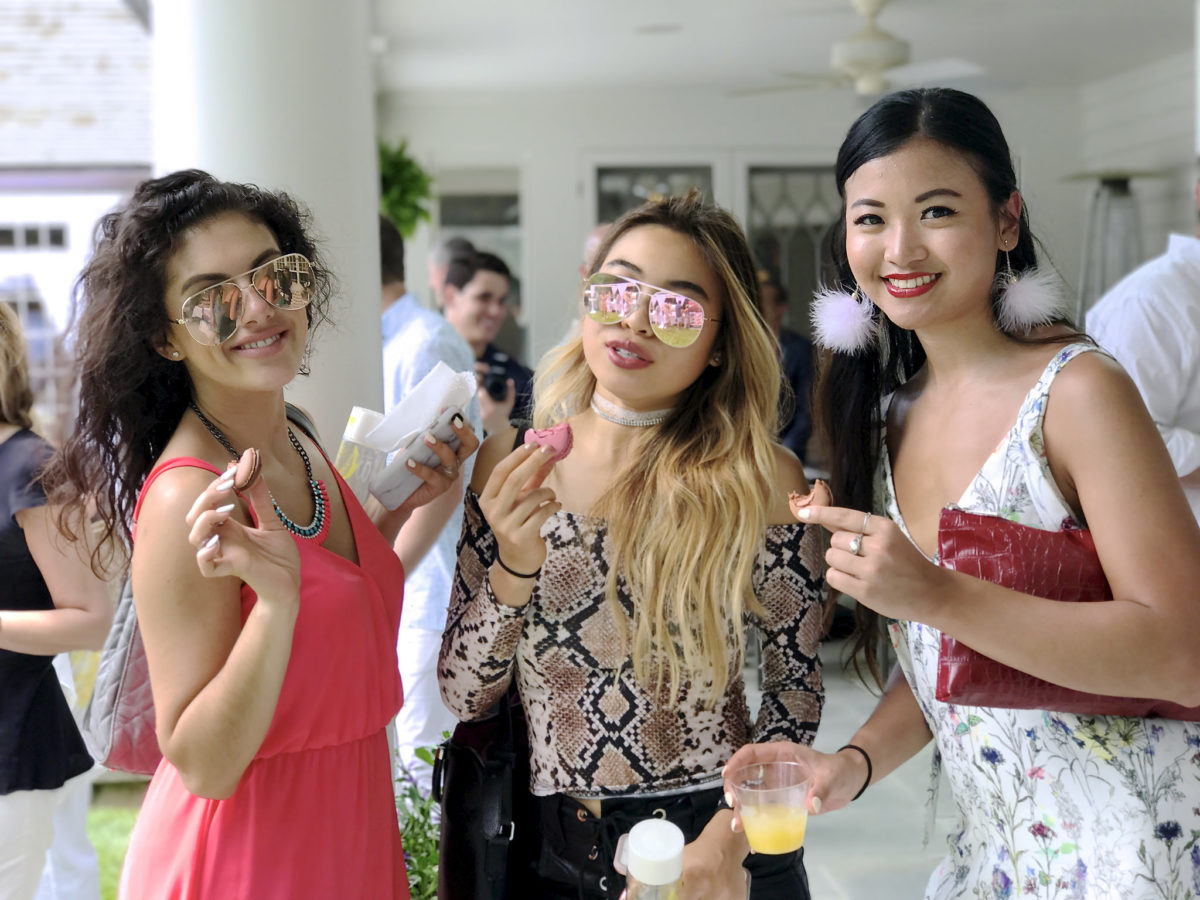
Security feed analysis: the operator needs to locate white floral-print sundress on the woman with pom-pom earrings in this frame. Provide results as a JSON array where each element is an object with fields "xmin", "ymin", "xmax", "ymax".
[{"xmin": 875, "ymin": 343, "xmax": 1200, "ymax": 900}]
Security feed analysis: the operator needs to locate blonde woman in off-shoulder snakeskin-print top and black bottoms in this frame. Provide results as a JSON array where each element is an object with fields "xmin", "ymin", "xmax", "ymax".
[{"xmin": 438, "ymin": 192, "xmax": 823, "ymax": 900}]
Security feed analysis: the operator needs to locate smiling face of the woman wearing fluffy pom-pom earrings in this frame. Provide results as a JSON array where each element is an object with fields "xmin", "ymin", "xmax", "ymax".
[{"xmin": 845, "ymin": 138, "xmax": 1020, "ymax": 329}]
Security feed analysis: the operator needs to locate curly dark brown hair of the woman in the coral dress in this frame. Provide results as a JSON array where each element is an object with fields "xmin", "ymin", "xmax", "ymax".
[{"xmin": 44, "ymin": 169, "xmax": 334, "ymax": 566}]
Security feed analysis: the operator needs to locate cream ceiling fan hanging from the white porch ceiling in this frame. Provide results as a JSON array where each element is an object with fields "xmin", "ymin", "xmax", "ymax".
[{"xmin": 731, "ymin": 0, "xmax": 984, "ymax": 96}]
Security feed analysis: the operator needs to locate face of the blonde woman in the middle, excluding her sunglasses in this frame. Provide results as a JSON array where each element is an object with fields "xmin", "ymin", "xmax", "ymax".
[{"xmin": 582, "ymin": 224, "xmax": 725, "ymax": 410}]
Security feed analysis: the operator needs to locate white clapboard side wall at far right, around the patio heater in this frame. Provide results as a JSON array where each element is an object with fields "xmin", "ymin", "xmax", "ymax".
[{"xmin": 1080, "ymin": 53, "xmax": 1198, "ymax": 264}]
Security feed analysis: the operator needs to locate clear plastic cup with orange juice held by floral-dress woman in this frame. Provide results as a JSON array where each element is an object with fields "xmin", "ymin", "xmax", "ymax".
[{"xmin": 732, "ymin": 762, "xmax": 809, "ymax": 853}]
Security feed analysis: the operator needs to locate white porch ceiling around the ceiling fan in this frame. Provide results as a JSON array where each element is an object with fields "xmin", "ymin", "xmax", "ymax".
[{"xmin": 373, "ymin": 0, "xmax": 1196, "ymax": 96}]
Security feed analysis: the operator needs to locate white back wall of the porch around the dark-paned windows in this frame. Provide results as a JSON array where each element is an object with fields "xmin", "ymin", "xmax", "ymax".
[{"xmin": 377, "ymin": 84, "xmax": 1087, "ymax": 364}]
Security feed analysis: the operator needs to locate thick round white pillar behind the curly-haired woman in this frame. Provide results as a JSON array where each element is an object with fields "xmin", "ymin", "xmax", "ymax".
[{"xmin": 152, "ymin": 0, "xmax": 383, "ymax": 444}]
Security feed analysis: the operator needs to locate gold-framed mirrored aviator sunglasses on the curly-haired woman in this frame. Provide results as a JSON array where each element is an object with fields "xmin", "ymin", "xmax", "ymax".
[{"xmin": 173, "ymin": 253, "xmax": 314, "ymax": 347}]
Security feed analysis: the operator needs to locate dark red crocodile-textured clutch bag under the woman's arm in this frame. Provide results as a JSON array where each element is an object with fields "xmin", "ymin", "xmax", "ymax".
[{"xmin": 936, "ymin": 506, "xmax": 1200, "ymax": 721}]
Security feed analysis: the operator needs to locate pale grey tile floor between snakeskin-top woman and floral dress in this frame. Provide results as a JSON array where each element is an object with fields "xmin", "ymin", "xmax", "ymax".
[{"xmin": 746, "ymin": 642, "xmax": 953, "ymax": 900}]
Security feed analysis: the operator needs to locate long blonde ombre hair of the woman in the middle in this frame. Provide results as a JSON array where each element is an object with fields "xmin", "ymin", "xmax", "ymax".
[{"xmin": 534, "ymin": 191, "xmax": 780, "ymax": 703}]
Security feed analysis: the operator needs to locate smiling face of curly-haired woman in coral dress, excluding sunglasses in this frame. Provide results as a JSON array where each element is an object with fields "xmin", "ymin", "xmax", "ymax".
[{"xmin": 160, "ymin": 212, "xmax": 308, "ymax": 392}]
